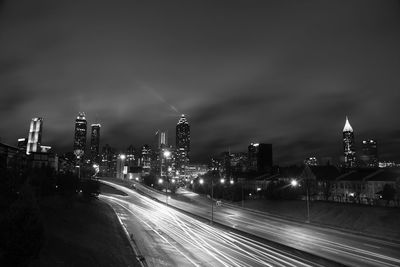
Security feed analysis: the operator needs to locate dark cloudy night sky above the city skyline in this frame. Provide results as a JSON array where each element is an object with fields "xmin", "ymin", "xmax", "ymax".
[{"xmin": 0, "ymin": 0, "xmax": 400, "ymax": 164}]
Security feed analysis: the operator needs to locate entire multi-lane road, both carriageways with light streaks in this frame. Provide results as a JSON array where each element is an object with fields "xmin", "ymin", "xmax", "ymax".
[{"xmin": 102, "ymin": 182, "xmax": 400, "ymax": 266}]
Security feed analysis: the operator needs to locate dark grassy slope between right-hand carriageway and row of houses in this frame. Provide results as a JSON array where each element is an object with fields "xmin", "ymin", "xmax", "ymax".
[{"xmin": 238, "ymin": 199, "xmax": 400, "ymax": 240}]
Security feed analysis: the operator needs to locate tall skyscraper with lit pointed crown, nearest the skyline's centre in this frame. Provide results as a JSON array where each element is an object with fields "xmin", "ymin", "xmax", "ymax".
[{"xmin": 176, "ymin": 114, "xmax": 190, "ymax": 175}]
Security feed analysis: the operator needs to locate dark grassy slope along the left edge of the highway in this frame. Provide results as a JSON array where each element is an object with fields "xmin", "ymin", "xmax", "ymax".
[{"xmin": 33, "ymin": 188, "xmax": 139, "ymax": 266}]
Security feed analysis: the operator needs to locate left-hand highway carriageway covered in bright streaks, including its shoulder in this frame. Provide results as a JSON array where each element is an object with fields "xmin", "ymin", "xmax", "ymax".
[{"xmin": 100, "ymin": 181, "xmax": 323, "ymax": 267}]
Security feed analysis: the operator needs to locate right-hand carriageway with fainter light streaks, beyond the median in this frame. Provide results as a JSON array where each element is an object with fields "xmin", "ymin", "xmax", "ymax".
[{"xmin": 101, "ymin": 179, "xmax": 400, "ymax": 266}]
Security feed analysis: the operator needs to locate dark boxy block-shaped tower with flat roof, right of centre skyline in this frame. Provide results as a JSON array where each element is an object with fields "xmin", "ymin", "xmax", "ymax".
[{"xmin": 248, "ymin": 143, "xmax": 272, "ymax": 174}]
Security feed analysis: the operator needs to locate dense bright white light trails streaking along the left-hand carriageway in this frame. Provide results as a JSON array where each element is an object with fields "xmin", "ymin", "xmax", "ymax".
[{"xmin": 101, "ymin": 188, "xmax": 315, "ymax": 267}]
